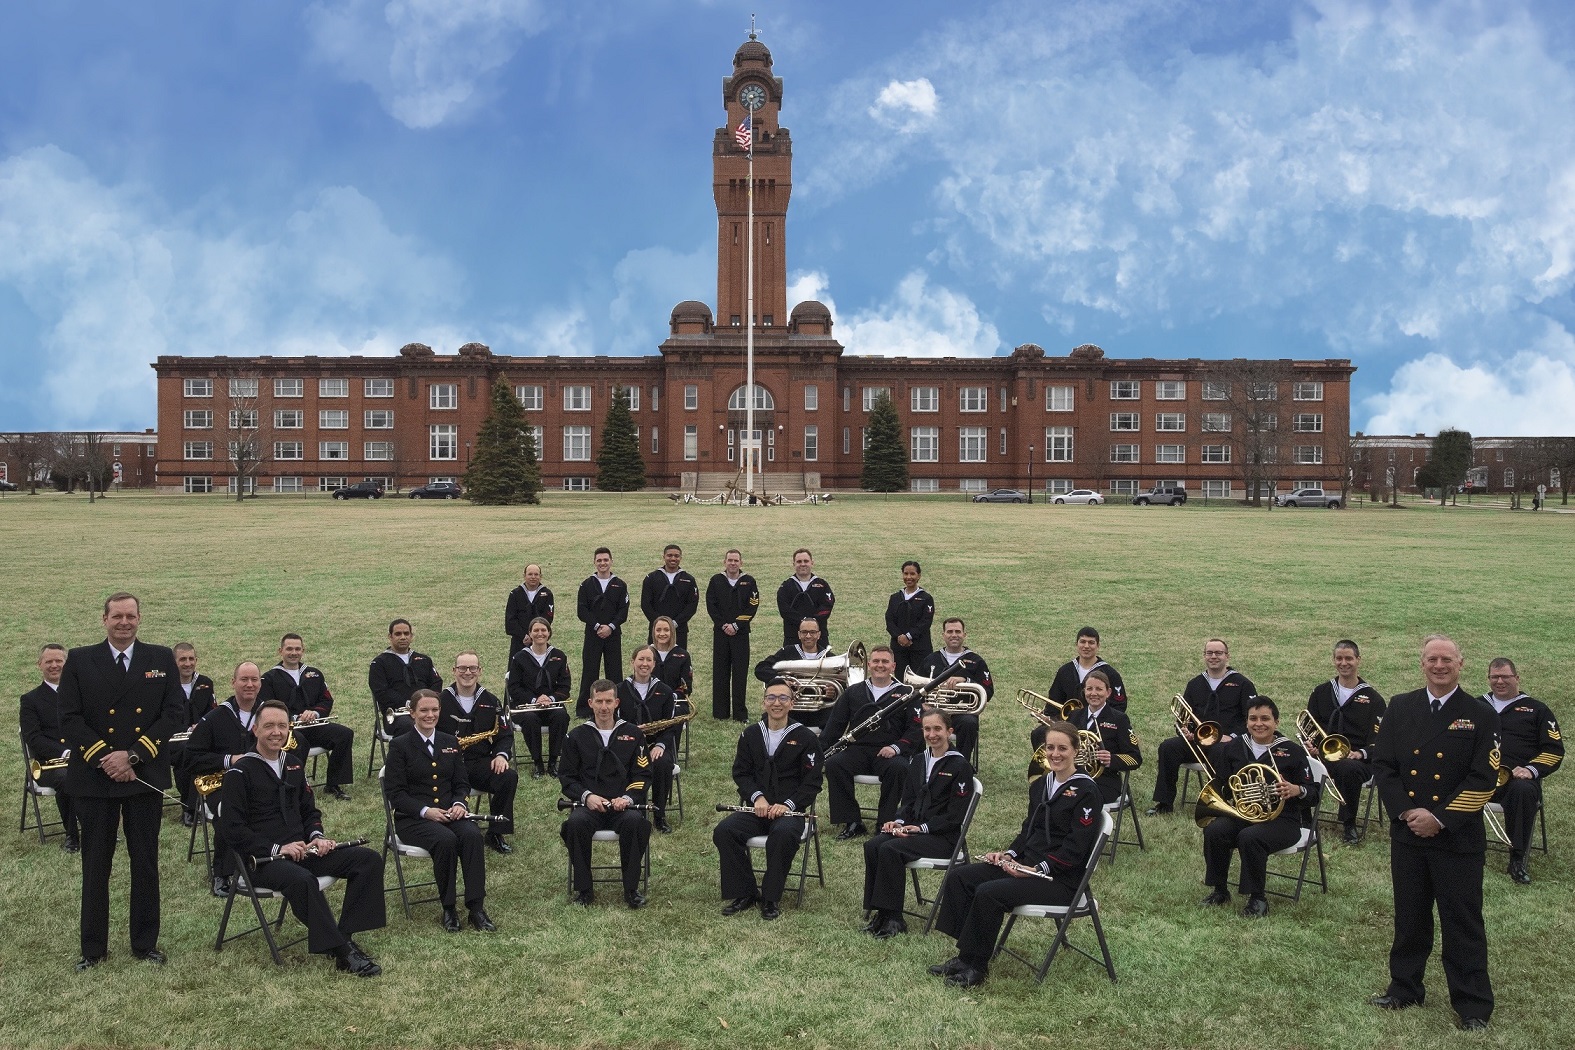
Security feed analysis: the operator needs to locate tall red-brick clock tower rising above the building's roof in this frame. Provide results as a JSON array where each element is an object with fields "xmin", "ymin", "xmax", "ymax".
[{"xmin": 712, "ymin": 33, "xmax": 792, "ymax": 331}]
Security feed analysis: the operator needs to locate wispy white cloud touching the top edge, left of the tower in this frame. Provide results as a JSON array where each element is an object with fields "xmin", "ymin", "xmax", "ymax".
[{"xmin": 306, "ymin": 0, "xmax": 551, "ymax": 128}]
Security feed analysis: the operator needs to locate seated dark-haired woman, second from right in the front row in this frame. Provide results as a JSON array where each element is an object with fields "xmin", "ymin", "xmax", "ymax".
[{"xmin": 863, "ymin": 708, "xmax": 973, "ymax": 941}]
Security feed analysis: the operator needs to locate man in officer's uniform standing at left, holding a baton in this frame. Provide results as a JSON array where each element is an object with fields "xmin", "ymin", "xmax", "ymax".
[{"xmin": 60, "ymin": 592, "xmax": 186, "ymax": 971}]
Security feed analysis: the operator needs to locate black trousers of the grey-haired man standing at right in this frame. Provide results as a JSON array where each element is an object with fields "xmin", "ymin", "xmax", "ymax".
[{"xmin": 1389, "ymin": 837, "xmax": 1493, "ymax": 1020}]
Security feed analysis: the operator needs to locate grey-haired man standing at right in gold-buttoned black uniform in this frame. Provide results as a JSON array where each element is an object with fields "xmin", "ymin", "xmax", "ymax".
[{"xmin": 1370, "ymin": 634, "xmax": 1499, "ymax": 1030}]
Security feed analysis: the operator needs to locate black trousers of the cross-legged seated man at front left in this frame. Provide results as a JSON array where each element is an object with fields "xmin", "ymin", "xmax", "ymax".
[{"xmin": 252, "ymin": 845, "xmax": 387, "ymax": 952}]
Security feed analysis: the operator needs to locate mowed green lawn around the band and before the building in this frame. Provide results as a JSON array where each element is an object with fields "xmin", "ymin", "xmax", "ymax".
[{"xmin": 0, "ymin": 494, "xmax": 1575, "ymax": 1050}]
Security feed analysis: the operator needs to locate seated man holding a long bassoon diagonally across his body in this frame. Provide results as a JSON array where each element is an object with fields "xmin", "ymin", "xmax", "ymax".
[{"xmin": 822, "ymin": 645, "xmax": 920, "ymax": 842}]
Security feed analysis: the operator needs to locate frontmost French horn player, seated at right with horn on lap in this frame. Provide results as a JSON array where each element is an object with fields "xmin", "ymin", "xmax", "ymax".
[{"xmin": 1199, "ymin": 696, "xmax": 1318, "ymax": 919}]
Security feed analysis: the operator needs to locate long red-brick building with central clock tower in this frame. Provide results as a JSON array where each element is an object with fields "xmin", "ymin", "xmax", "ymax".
[{"xmin": 153, "ymin": 39, "xmax": 1355, "ymax": 497}]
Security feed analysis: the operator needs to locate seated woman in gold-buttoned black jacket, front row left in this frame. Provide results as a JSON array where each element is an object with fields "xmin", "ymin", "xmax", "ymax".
[{"xmin": 383, "ymin": 690, "xmax": 498, "ymax": 934}]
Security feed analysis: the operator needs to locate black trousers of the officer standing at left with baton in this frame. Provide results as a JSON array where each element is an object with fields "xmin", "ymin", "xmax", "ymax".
[{"xmin": 76, "ymin": 789, "xmax": 164, "ymax": 959}]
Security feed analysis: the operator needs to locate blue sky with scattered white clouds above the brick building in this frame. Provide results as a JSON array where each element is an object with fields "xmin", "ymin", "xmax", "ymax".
[{"xmin": 0, "ymin": 0, "xmax": 1575, "ymax": 434}]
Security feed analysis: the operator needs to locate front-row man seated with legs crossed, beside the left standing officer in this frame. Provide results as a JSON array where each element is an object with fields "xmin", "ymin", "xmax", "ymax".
[{"xmin": 219, "ymin": 702, "xmax": 386, "ymax": 978}]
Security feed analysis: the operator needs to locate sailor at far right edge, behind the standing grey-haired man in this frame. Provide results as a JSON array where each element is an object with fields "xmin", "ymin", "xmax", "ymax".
[{"xmin": 1482, "ymin": 656, "xmax": 1564, "ymax": 886}]
